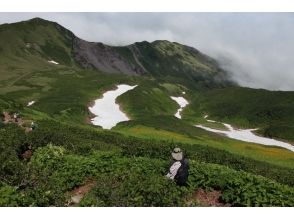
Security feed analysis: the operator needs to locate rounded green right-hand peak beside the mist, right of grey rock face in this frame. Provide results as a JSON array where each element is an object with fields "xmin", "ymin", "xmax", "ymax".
[{"xmin": 113, "ymin": 40, "xmax": 232, "ymax": 88}]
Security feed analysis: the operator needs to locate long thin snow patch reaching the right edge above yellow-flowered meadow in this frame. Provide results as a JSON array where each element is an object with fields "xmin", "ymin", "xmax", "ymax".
[{"xmin": 196, "ymin": 116, "xmax": 294, "ymax": 151}]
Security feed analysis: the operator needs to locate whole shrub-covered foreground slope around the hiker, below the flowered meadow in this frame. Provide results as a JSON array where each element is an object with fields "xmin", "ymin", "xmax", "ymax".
[{"xmin": 0, "ymin": 121, "xmax": 294, "ymax": 206}]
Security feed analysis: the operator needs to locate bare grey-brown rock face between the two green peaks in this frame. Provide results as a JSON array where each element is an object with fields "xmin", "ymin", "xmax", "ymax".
[{"xmin": 73, "ymin": 38, "xmax": 145, "ymax": 75}]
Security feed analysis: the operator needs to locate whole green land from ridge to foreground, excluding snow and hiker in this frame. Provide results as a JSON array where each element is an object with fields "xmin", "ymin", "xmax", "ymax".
[{"xmin": 0, "ymin": 18, "xmax": 294, "ymax": 206}]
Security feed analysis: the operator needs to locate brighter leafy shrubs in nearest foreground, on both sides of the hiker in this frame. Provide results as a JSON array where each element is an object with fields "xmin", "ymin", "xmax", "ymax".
[{"xmin": 0, "ymin": 145, "xmax": 294, "ymax": 206}]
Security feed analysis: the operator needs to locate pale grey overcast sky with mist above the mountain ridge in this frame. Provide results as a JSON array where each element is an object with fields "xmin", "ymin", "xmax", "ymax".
[{"xmin": 0, "ymin": 13, "xmax": 294, "ymax": 91}]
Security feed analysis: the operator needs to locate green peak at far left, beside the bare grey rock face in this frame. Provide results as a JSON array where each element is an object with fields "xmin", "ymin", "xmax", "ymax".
[{"xmin": 0, "ymin": 18, "xmax": 75, "ymax": 74}]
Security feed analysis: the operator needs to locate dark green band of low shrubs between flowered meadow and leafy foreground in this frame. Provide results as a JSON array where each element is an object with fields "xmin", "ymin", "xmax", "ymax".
[{"xmin": 28, "ymin": 121, "xmax": 294, "ymax": 186}]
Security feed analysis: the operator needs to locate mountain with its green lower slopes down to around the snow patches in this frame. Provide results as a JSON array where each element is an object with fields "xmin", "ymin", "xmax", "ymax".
[{"xmin": 0, "ymin": 18, "xmax": 294, "ymax": 144}]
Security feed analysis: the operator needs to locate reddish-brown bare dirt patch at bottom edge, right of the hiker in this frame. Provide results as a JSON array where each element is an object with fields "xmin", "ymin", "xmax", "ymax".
[{"xmin": 193, "ymin": 189, "xmax": 231, "ymax": 207}]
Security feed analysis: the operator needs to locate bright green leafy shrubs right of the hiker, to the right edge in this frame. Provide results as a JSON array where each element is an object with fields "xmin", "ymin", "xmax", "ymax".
[{"xmin": 189, "ymin": 161, "xmax": 294, "ymax": 206}]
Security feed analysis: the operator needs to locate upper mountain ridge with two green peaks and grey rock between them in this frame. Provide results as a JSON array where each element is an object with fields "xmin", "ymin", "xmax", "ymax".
[{"xmin": 0, "ymin": 18, "xmax": 233, "ymax": 87}]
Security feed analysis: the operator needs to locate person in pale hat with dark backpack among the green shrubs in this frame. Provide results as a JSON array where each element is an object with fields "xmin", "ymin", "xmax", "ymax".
[{"xmin": 166, "ymin": 148, "xmax": 189, "ymax": 186}]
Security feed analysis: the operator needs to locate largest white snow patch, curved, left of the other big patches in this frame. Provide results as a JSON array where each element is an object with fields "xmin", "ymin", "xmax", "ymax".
[{"xmin": 89, "ymin": 84, "xmax": 136, "ymax": 129}]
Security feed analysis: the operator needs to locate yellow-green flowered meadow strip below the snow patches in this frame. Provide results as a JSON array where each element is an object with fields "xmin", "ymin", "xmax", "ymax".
[{"xmin": 114, "ymin": 116, "xmax": 294, "ymax": 168}]
